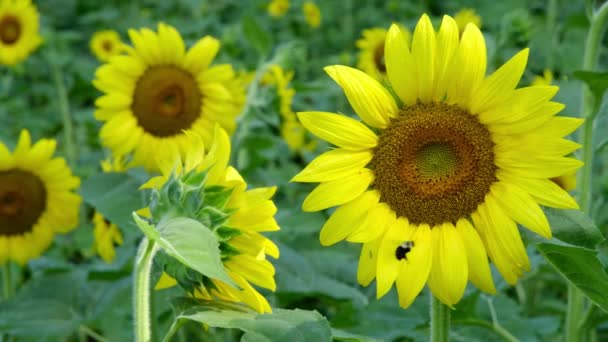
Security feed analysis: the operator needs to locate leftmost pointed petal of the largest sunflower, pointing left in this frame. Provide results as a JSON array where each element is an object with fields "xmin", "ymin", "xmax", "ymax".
[{"xmin": 291, "ymin": 148, "xmax": 372, "ymax": 182}]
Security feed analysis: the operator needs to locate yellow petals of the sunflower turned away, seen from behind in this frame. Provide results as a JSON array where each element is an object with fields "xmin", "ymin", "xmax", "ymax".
[{"xmin": 143, "ymin": 126, "xmax": 279, "ymax": 312}]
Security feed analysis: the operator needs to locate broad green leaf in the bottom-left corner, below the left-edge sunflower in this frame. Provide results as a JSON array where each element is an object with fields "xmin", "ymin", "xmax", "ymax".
[{"xmin": 0, "ymin": 298, "xmax": 81, "ymax": 338}]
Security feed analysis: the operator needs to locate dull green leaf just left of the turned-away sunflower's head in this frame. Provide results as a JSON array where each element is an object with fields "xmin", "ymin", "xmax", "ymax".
[{"xmin": 80, "ymin": 173, "xmax": 144, "ymax": 230}]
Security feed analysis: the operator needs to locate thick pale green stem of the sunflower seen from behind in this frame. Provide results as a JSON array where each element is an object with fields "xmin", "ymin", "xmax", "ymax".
[{"xmin": 133, "ymin": 237, "xmax": 158, "ymax": 342}]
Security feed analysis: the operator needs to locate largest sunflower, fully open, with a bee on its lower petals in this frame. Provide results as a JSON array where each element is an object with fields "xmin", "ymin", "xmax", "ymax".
[{"xmin": 293, "ymin": 15, "xmax": 582, "ymax": 308}]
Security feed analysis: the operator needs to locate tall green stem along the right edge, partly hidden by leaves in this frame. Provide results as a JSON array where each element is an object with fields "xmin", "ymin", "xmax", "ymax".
[{"xmin": 566, "ymin": 2, "xmax": 608, "ymax": 342}]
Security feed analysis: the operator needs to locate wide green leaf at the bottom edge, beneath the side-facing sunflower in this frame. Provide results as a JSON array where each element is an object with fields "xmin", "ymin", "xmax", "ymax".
[{"xmin": 165, "ymin": 301, "xmax": 331, "ymax": 342}]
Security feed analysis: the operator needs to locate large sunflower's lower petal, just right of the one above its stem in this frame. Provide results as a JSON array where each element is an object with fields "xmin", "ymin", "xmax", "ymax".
[{"xmin": 456, "ymin": 218, "xmax": 496, "ymax": 294}]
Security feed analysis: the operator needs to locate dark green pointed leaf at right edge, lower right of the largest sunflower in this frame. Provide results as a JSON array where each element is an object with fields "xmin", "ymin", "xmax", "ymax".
[{"xmin": 538, "ymin": 243, "xmax": 608, "ymax": 311}]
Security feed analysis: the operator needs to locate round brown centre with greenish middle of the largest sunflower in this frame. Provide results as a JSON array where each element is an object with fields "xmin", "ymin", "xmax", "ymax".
[{"xmin": 370, "ymin": 103, "xmax": 497, "ymax": 227}]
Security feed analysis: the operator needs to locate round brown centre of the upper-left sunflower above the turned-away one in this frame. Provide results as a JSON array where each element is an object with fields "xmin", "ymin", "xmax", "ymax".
[{"xmin": 131, "ymin": 65, "xmax": 202, "ymax": 137}]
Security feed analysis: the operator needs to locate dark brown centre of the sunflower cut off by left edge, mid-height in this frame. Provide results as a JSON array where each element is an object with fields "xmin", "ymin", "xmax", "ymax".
[{"xmin": 0, "ymin": 169, "xmax": 47, "ymax": 236}]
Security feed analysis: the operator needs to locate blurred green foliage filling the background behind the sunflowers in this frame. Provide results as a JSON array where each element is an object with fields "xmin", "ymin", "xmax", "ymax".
[{"xmin": 0, "ymin": 0, "xmax": 608, "ymax": 341}]
